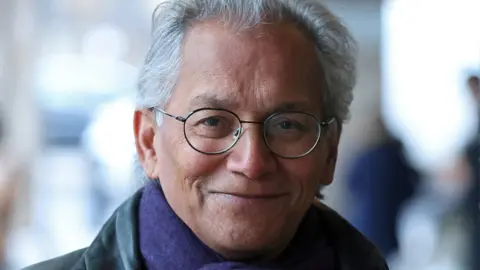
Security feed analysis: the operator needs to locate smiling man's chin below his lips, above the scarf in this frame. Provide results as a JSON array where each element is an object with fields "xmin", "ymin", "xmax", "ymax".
[{"xmin": 197, "ymin": 195, "xmax": 300, "ymax": 259}]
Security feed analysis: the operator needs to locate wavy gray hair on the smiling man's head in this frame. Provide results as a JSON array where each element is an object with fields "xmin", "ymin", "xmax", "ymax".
[{"xmin": 136, "ymin": 0, "xmax": 357, "ymax": 122}]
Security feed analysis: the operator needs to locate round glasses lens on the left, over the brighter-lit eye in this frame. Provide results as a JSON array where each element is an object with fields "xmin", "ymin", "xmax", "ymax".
[{"xmin": 185, "ymin": 109, "xmax": 240, "ymax": 154}]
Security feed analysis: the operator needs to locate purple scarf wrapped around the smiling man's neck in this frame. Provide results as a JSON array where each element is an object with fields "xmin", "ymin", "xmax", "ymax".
[{"xmin": 139, "ymin": 181, "xmax": 336, "ymax": 270}]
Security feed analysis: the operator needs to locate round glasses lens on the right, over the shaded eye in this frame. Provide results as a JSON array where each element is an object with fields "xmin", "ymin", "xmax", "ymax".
[{"xmin": 264, "ymin": 112, "xmax": 321, "ymax": 158}]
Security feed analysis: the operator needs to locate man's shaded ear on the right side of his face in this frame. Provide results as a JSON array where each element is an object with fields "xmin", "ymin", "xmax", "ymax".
[{"xmin": 320, "ymin": 120, "xmax": 342, "ymax": 186}]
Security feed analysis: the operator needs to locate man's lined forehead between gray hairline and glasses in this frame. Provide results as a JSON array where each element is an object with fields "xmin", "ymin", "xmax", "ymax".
[{"xmin": 171, "ymin": 21, "xmax": 324, "ymax": 112}]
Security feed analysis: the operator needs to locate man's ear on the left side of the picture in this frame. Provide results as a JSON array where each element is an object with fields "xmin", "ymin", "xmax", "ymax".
[{"xmin": 133, "ymin": 110, "xmax": 157, "ymax": 179}]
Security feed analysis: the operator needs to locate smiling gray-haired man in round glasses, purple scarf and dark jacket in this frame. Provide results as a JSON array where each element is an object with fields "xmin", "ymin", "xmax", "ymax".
[{"xmin": 24, "ymin": 0, "xmax": 387, "ymax": 270}]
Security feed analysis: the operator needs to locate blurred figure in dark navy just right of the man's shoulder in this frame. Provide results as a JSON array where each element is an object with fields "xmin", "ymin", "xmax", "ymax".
[{"xmin": 347, "ymin": 119, "xmax": 419, "ymax": 256}]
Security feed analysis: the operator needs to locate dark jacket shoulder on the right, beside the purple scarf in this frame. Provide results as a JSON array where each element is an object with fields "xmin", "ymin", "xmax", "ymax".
[{"xmin": 314, "ymin": 200, "xmax": 388, "ymax": 270}]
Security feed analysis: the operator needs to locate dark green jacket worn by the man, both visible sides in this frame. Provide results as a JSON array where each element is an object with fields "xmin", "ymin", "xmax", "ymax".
[{"xmin": 24, "ymin": 190, "xmax": 388, "ymax": 270}]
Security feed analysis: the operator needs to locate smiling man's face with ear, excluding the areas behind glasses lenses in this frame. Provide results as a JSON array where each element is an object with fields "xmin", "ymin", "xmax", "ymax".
[{"xmin": 135, "ymin": 21, "xmax": 339, "ymax": 259}]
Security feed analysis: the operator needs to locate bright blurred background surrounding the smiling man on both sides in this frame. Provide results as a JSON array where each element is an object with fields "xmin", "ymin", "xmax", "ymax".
[{"xmin": 0, "ymin": 0, "xmax": 480, "ymax": 270}]
